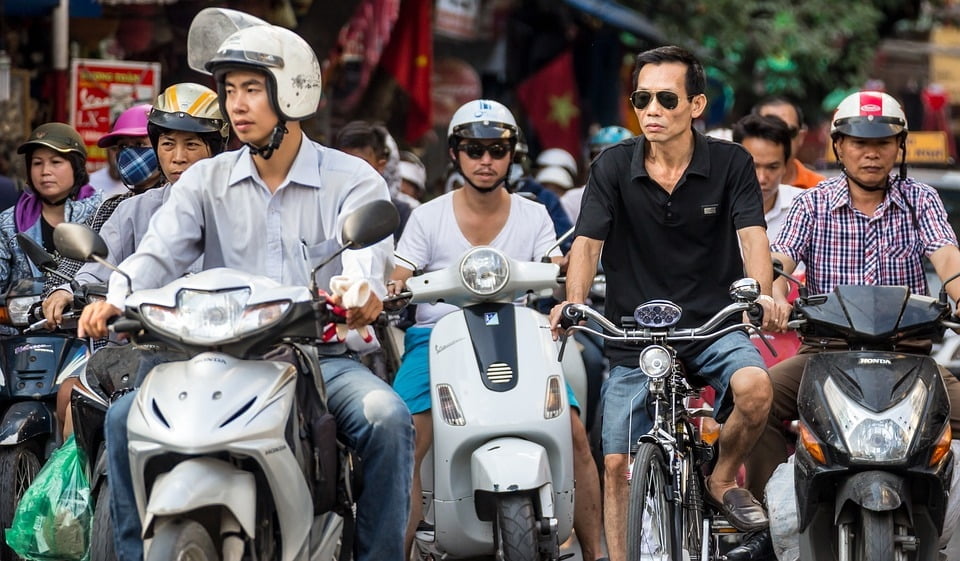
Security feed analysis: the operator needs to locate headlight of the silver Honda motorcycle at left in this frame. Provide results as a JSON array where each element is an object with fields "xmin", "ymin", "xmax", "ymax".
[{"xmin": 140, "ymin": 288, "xmax": 291, "ymax": 344}]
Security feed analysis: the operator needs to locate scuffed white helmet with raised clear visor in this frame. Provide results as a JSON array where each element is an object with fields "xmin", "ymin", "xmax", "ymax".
[{"xmin": 204, "ymin": 25, "xmax": 321, "ymax": 121}]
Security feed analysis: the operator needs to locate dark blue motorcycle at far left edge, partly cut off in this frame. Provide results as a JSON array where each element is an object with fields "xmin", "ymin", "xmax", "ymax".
[{"xmin": 0, "ymin": 235, "xmax": 87, "ymax": 561}]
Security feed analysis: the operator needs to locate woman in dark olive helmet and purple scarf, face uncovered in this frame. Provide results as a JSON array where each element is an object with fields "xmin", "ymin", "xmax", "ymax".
[{"xmin": 0, "ymin": 123, "xmax": 100, "ymax": 291}]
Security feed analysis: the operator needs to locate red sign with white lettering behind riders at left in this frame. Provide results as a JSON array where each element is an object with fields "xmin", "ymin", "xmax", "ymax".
[{"xmin": 70, "ymin": 59, "xmax": 160, "ymax": 172}]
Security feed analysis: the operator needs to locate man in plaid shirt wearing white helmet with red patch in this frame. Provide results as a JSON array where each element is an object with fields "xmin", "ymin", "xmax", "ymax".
[{"xmin": 746, "ymin": 91, "xmax": 960, "ymax": 551}]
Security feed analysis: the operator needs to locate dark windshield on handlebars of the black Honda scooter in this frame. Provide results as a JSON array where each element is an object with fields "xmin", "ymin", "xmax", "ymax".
[{"xmin": 802, "ymin": 285, "xmax": 942, "ymax": 339}]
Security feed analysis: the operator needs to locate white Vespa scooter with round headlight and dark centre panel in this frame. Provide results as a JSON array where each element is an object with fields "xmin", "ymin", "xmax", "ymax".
[{"xmin": 407, "ymin": 247, "xmax": 582, "ymax": 561}]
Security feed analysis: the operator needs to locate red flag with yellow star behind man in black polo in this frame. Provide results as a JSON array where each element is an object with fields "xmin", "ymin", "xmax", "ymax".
[{"xmin": 517, "ymin": 51, "xmax": 580, "ymax": 157}]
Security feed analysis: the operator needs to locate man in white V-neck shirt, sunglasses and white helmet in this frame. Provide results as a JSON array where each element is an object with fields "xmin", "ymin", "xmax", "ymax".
[{"xmin": 390, "ymin": 99, "xmax": 602, "ymax": 561}]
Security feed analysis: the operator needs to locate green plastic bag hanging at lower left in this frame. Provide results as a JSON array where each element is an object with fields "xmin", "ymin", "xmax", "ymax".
[{"xmin": 6, "ymin": 435, "xmax": 93, "ymax": 561}]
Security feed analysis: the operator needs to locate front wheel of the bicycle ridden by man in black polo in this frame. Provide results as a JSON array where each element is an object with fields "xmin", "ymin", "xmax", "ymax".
[{"xmin": 627, "ymin": 442, "xmax": 676, "ymax": 561}]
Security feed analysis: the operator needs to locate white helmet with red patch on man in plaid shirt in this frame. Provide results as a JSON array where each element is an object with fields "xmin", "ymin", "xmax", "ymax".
[{"xmin": 830, "ymin": 91, "xmax": 908, "ymax": 181}]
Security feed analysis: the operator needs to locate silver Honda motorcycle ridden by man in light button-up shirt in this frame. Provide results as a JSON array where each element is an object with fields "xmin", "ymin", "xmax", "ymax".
[{"xmin": 54, "ymin": 201, "xmax": 397, "ymax": 561}]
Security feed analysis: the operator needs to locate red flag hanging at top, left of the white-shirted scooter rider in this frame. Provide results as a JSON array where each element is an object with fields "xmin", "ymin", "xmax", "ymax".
[{"xmin": 380, "ymin": 0, "xmax": 433, "ymax": 142}]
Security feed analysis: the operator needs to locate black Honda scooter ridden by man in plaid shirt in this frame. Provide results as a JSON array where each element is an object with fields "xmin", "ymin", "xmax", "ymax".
[{"xmin": 784, "ymin": 275, "xmax": 960, "ymax": 561}]
